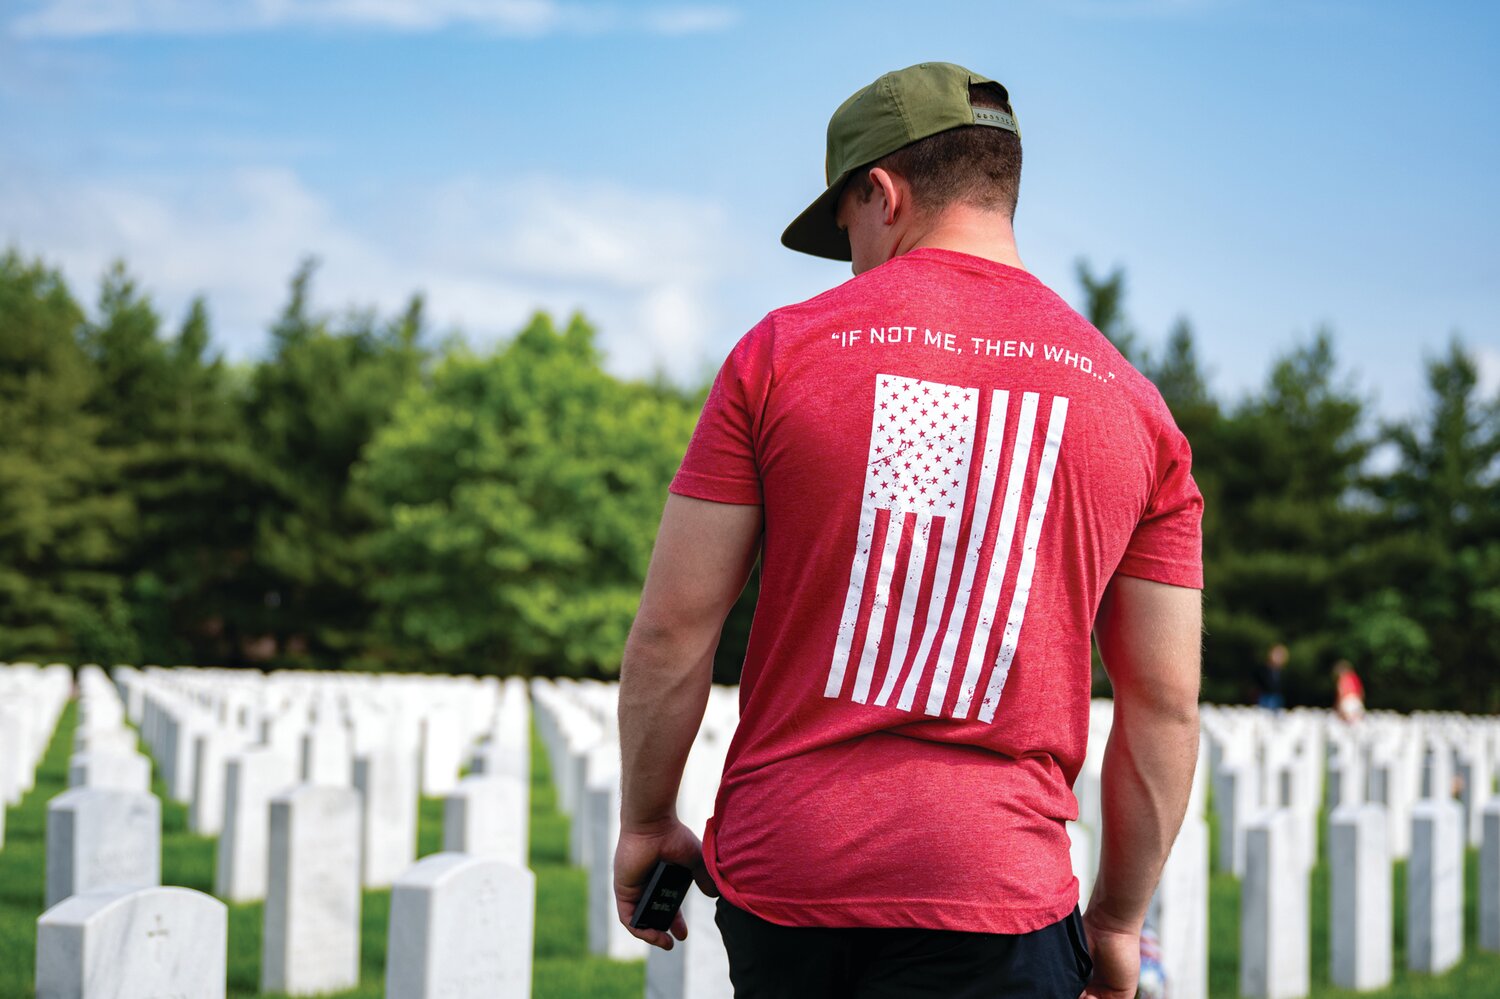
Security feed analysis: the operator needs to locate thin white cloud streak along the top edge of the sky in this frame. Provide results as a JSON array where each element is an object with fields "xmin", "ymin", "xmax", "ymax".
[{"xmin": 11, "ymin": 0, "xmax": 740, "ymax": 38}]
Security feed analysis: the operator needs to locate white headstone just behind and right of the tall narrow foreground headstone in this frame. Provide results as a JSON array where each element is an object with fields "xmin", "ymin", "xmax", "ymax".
[{"xmin": 354, "ymin": 744, "xmax": 417, "ymax": 888}]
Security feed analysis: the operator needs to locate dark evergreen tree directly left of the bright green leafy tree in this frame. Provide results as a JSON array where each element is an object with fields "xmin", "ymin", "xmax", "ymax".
[{"xmin": 241, "ymin": 261, "xmax": 426, "ymax": 668}]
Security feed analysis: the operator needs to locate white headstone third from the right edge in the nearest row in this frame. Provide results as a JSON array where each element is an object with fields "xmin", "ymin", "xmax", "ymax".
[{"xmin": 1328, "ymin": 804, "xmax": 1392, "ymax": 992}]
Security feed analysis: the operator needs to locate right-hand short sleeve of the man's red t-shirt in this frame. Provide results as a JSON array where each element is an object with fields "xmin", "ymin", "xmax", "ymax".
[{"xmin": 1116, "ymin": 423, "xmax": 1203, "ymax": 590}]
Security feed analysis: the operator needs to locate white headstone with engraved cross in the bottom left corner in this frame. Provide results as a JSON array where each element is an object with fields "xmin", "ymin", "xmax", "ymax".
[{"xmin": 36, "ymin": 888, "xmax": 230, "ymax": 999}]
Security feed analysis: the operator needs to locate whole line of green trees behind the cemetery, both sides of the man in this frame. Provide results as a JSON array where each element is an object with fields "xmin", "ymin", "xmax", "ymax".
[{"xmin": 0, "ymin": 251, "xmax": 1500, "ymax": 711}]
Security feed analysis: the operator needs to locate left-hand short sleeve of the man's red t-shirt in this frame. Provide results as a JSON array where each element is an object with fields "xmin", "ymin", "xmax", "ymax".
[{"xmin": 671, "ymin": 318, "xmax": 771, "ymax": 506}]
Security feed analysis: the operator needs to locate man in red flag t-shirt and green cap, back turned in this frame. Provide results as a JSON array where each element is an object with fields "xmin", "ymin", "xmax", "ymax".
[{"xmin": 615, "ymin": 63, "xmax": 1203, "ymax": 999}]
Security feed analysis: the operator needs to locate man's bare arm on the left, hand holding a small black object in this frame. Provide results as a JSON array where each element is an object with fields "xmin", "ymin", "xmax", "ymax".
[{"xmin": 615, "ymin": 494, "xmax": 762, "ymax": 950}]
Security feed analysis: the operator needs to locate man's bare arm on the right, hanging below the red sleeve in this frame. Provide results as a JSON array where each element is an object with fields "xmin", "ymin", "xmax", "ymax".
[{"xmin": 1085, "ymin": 576, "xmax": 1203, "ymax": 999}]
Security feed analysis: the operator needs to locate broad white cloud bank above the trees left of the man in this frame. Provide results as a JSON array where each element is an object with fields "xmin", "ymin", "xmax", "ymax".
[{"xmin": 0, "ymin": 161, "xmax": 729, "ymax": 380}]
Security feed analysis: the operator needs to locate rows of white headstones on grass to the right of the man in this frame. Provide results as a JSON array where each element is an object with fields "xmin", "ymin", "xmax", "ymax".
[{"xmin": 1202, "ymin": 708, "xmax": 1500, "ymax": 998}]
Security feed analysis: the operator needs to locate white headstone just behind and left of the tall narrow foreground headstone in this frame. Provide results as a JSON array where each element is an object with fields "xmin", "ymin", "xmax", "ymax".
[{"xmin": 213, "ymin": 746, "xmax": 296, "ymax": 902}]
